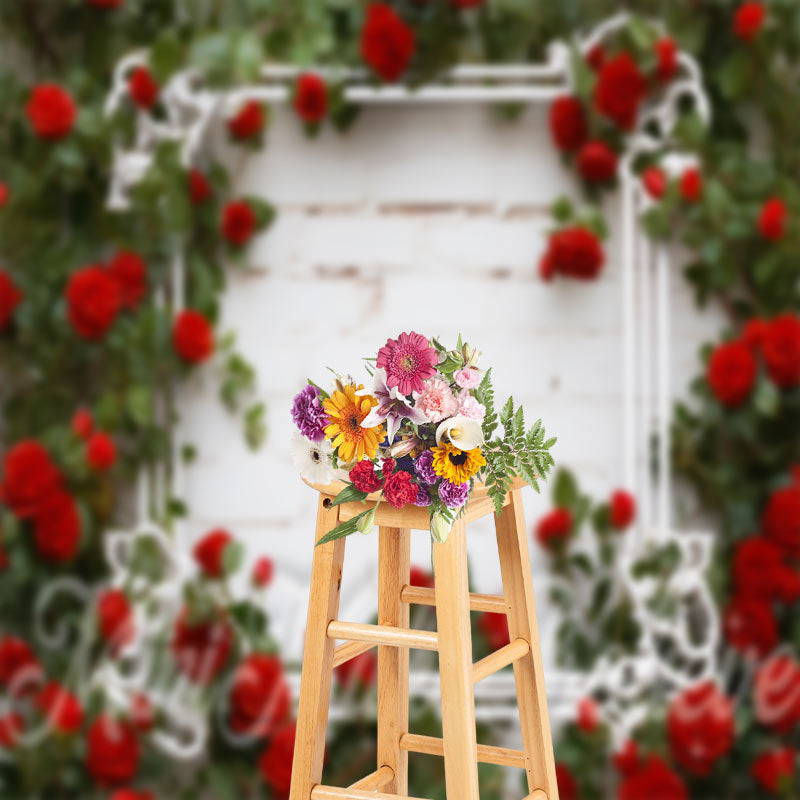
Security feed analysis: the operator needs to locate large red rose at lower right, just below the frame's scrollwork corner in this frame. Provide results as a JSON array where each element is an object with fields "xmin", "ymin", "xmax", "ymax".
[{"xmin": 667, "ymin": 681, "xmax": 734, "ymax": 775}]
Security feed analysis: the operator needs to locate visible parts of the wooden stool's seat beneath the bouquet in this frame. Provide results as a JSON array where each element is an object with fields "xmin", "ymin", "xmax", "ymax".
[{"xmin": 303, "ymin": 478, "xmax": 527, "ymax": 531}]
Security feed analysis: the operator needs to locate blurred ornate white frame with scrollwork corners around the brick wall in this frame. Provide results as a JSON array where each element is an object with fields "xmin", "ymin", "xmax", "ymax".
[{"xmin": 101, "ymin": 14, "xmax": 718, "ymax": 752}]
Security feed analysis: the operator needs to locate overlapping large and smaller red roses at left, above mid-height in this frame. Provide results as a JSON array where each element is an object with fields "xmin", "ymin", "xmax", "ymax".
[{"xmin": 64, "ymin": 250, "xmax": 147, "ymax": 340}]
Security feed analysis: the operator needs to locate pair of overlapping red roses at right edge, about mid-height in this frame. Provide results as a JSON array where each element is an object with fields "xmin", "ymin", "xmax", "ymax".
[{"xmin": 706, "ymin": 312, "xmax": 800, "ymax": 408}]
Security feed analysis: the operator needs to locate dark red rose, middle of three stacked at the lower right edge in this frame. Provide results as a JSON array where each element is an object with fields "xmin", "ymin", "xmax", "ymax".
[{"xmin": 731, "ymin": 536, "xmax": 800, "ymax": 604}]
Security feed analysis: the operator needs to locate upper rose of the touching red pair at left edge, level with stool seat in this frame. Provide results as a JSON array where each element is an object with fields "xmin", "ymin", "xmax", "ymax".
[{"xmin": 0, "ymin": 439, "xmax": 61, "ymax": 517}]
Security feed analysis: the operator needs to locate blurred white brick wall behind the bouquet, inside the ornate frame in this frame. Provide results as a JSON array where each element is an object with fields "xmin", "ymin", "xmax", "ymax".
[{"xmin": 178, "ymin": 106, "xmax": 718, "ymax": 662}]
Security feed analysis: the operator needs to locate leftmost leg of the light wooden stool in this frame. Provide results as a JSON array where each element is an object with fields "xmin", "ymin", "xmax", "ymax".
[{"xmin": 289, "ymin": 495, "xmax": 345, "ymax": 800}]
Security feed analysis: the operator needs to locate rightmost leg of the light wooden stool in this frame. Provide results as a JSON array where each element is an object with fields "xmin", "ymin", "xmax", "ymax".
[{"xmin": 495, "ymin": 490, "xmax": 558, "ymax": 800}]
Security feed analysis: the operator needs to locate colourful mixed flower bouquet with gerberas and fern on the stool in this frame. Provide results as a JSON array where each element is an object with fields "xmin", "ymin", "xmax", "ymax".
[{"xmin": 292, "ymin": 331, "xmax": 556, "ymax": 544}]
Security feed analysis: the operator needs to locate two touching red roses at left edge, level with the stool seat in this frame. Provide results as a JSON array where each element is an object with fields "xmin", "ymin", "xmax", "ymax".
[{"xmin": 0, "ymin": 439, "xmax": 81, "ymax": 564}]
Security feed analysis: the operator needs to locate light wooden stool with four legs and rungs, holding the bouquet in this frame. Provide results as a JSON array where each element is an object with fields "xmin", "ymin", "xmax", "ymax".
[{"xmin": 289, "ymin": 481, "xmax": 558, "ymax": 800}]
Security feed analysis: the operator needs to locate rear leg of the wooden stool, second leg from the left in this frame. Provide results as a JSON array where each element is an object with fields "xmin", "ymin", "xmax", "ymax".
[{"xmin": 378, "ymin": 527, "xmax": 411, "ymax": 795}]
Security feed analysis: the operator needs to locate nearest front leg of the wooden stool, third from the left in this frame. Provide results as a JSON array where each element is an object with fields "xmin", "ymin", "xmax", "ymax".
[{"xmin": 433, "ymin": 521, "xmax": 479, "ymax": 800}]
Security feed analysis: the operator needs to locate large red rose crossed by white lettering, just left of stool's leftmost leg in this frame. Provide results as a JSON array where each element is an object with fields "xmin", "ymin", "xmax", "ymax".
[{"xmin": 230, "ymin": 653, "xmax": 291, "ymax": 737}]
